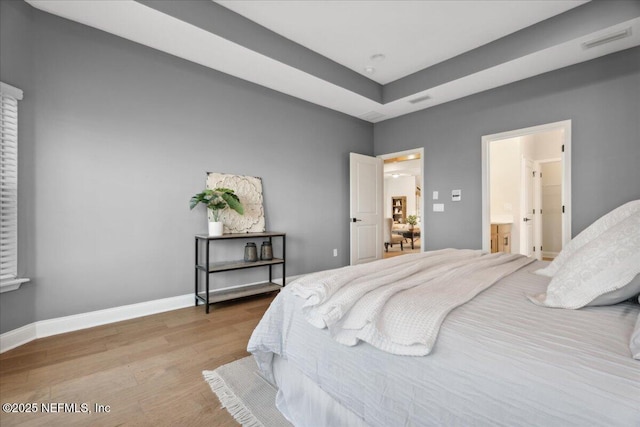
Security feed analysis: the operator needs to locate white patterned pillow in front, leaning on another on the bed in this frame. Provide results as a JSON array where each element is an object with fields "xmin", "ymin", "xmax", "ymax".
[{"xmin": 528, "ymin": 212, "xmax": 640, "ymax": 309}]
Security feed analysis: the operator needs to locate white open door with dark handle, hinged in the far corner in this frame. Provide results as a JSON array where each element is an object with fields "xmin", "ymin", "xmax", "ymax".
[{"xmin": 349, "ymin": 153, "xmax": 383, "ymax": 265}]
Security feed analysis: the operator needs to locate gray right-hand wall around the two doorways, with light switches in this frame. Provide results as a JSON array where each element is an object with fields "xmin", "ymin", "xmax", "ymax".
[{"xmin": 374, "ymin": 48, "xmax": 640, "ymax": 249}]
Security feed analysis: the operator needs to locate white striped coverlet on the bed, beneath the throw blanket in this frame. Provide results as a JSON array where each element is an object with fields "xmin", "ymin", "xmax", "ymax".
[{"xmin": 249, "ymin": 257, "xmax": 640, "ymax": 427}]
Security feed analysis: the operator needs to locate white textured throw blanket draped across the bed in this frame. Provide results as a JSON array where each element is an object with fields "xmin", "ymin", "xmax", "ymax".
[{"xmin": 290, "ymin": 249, "xmax": 533, "ymax": 356}]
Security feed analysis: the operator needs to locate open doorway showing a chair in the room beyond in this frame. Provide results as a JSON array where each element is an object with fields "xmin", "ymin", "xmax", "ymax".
[{"xmin": 378, "ymin": 148, "xmax": 424, "ymax": 258}]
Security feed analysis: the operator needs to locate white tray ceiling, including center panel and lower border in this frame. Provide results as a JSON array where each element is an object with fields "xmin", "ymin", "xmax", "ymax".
[{"xmin": 25, "ymin": 0, "xmax": 640, "ymax": 122}]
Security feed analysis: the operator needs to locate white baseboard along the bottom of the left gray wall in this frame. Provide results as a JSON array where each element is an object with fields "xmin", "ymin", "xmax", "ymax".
[{"xmin": 0, "ymin": 276, "xmax": 298, "ymax": 353}]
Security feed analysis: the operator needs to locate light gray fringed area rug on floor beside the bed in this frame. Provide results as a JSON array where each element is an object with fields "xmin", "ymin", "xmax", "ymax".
[{"xmin": 202, "ymin": 356, "xmax": 292, "ymax": 427}]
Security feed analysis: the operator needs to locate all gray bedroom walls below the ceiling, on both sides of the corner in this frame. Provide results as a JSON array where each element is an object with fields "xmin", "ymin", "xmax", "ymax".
[{"xmin": 0, "ymin": 0, "xmax": 640, "ymax": 333}]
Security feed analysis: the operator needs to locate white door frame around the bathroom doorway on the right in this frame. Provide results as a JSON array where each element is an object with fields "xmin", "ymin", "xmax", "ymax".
[{"xmin": 482, "ymin": 120, "xmax": 571, "ymax": 252}]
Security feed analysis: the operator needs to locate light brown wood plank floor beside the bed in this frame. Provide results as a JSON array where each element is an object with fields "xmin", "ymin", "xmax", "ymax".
[{"xmin": 0, "ymin": 294, "xmax": 275, "ymax": 427}]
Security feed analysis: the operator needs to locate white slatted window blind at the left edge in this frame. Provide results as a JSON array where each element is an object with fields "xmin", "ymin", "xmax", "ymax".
[{"xmin": 0, "ymin": 83, "xmax": 22, "ymax": 283}]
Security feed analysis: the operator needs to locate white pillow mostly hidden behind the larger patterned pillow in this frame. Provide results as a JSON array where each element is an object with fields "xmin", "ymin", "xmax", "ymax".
[{"xmin": 536, "ymin": 200, "xmax": 640, "ymax": 277}]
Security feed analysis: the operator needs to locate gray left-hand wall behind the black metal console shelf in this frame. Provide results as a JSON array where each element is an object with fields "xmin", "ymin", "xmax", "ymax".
[{"xmin": 0, "ymin": 0, "xmax": 373, "ymax": 332}]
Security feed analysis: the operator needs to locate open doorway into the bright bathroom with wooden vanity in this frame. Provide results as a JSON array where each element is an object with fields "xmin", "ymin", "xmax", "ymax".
[{"xmin": 482, "ymin": 121, "xmax": 571, "ymax": 260}]
